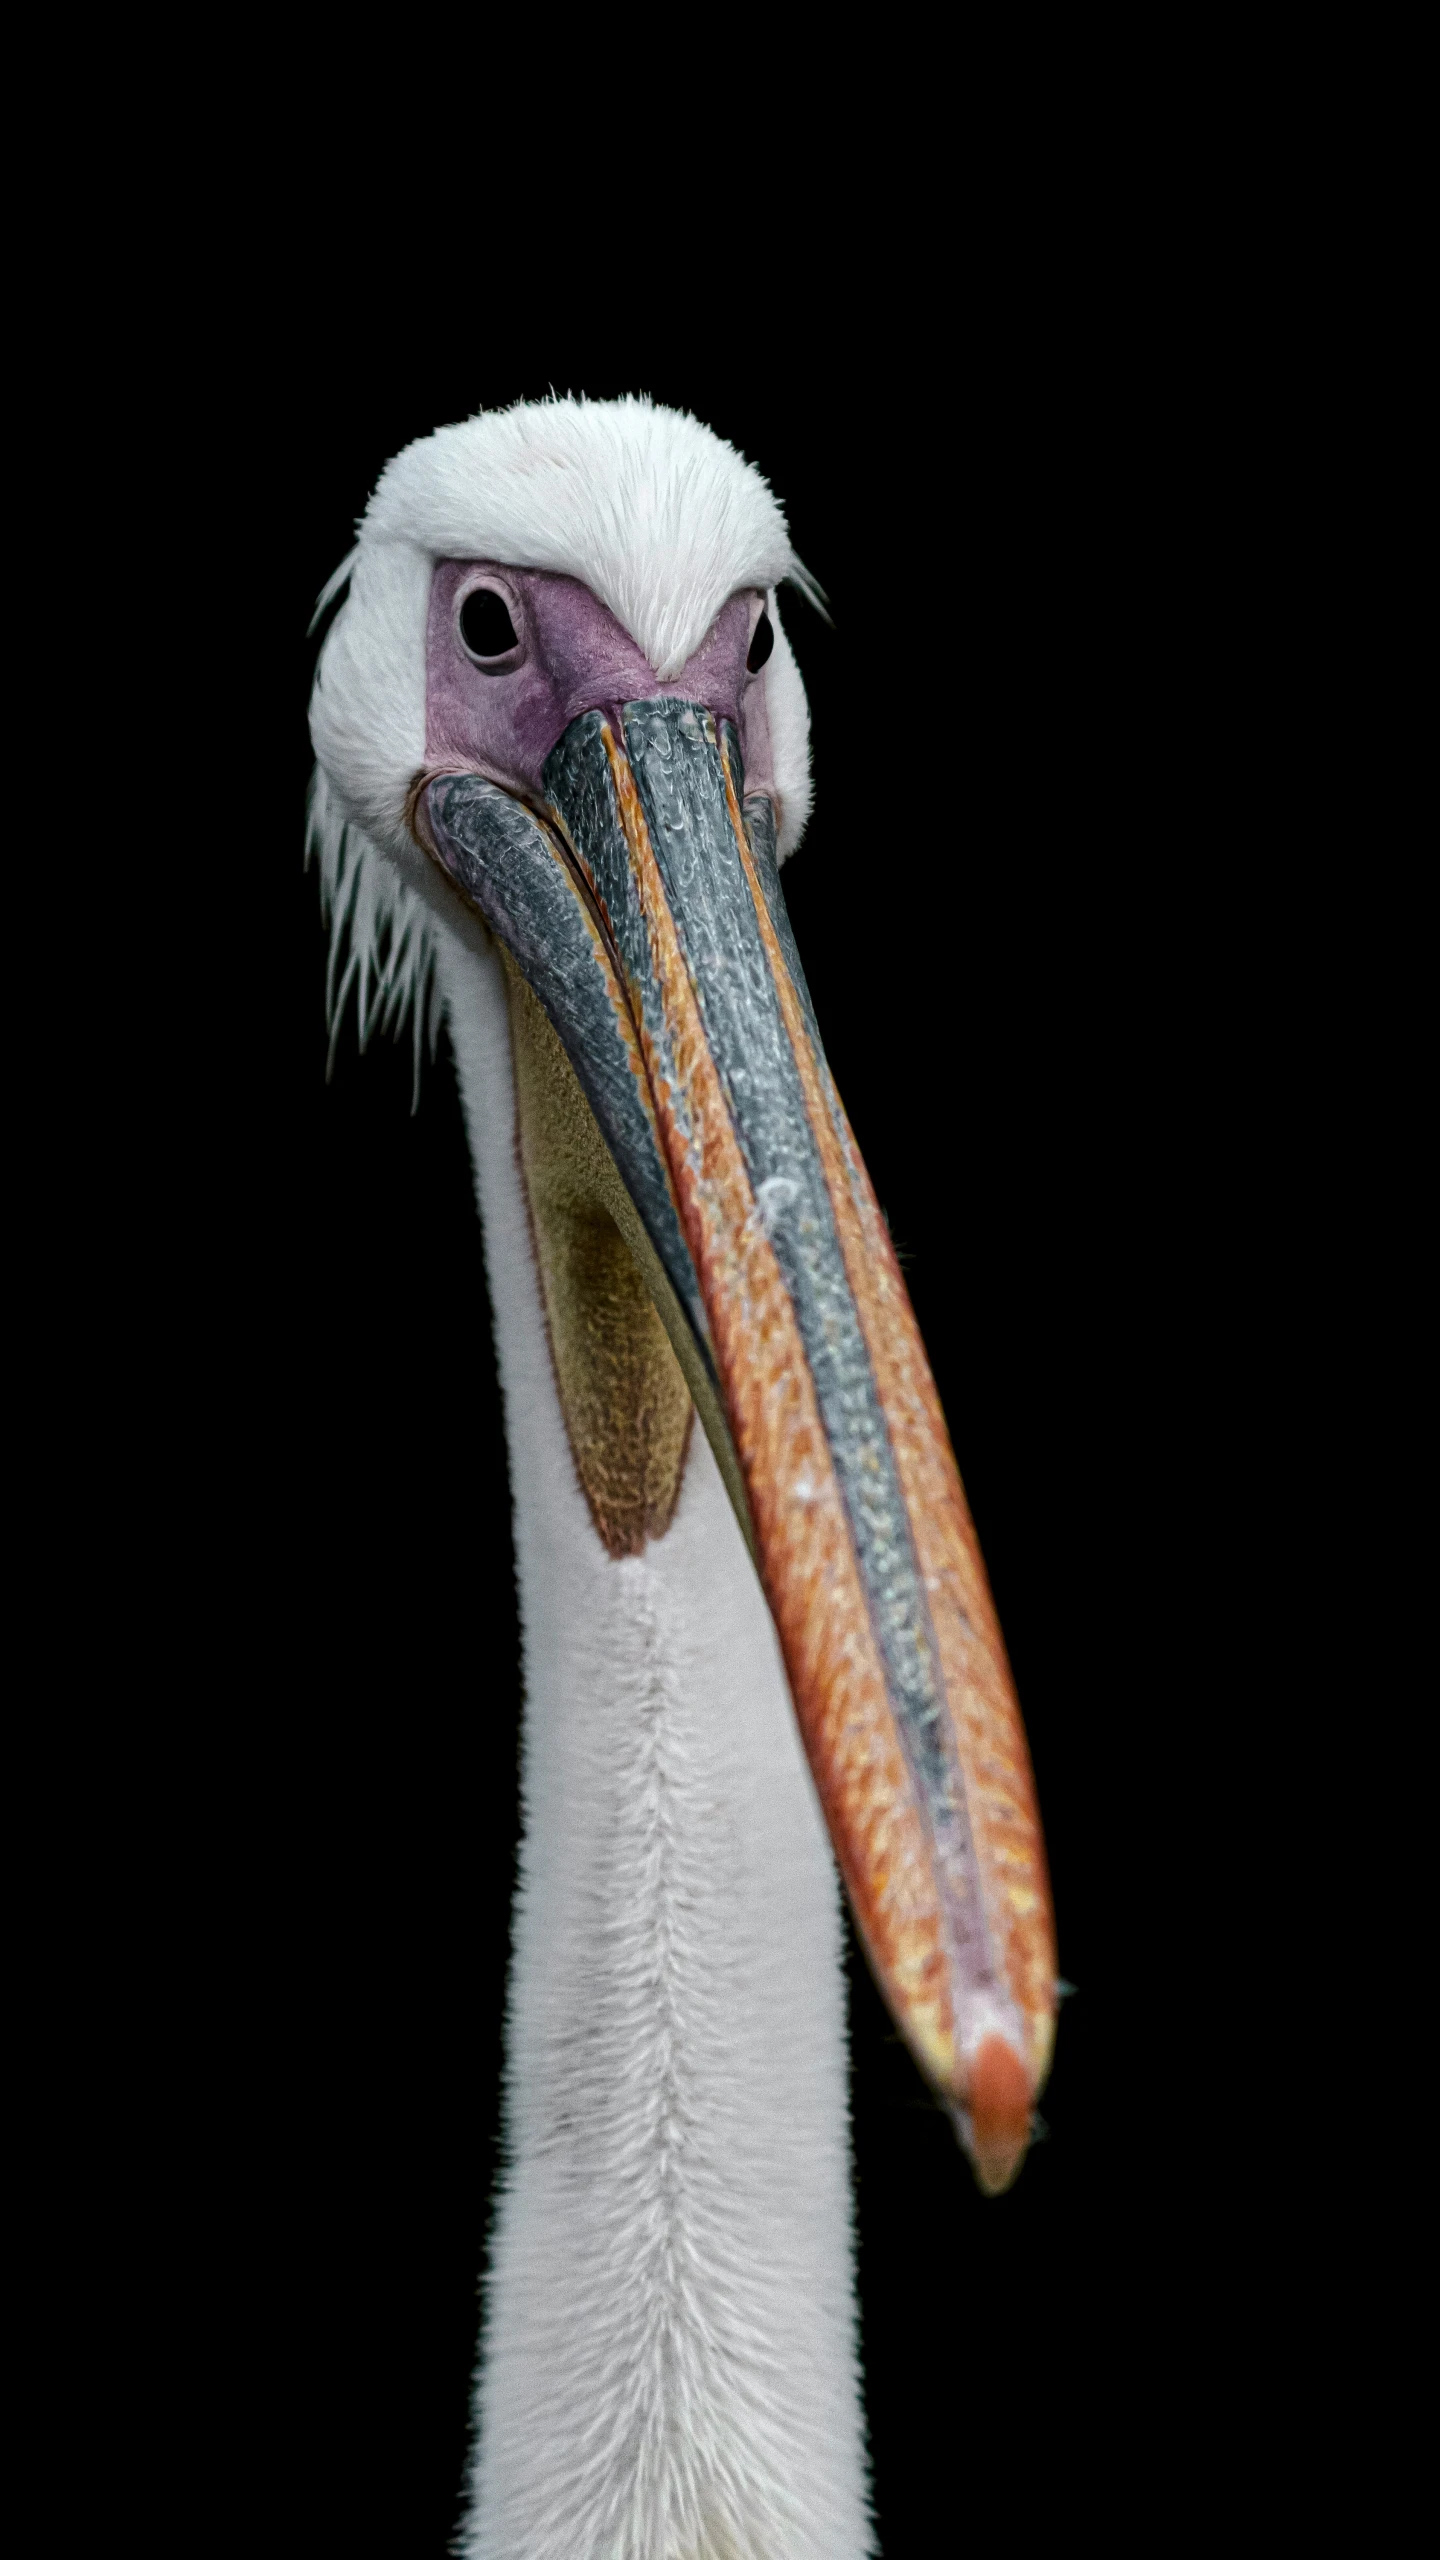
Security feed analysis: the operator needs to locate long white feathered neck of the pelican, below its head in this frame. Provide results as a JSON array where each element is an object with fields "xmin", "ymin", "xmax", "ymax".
[{"xmin": 441, "ymin": 937, "xmax": 874, "ymax": 2560}]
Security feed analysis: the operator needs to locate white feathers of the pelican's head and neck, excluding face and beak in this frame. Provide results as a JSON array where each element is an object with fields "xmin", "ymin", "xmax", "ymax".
[{"xmin": 313, "ymin": 402, "xmax": 874, "ymax": 2560}]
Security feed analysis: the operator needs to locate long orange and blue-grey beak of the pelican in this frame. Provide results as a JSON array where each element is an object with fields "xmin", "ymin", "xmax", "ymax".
[{"xmin": 425, "ymin": 699, "xmax": 1056, "ymax": 2194}]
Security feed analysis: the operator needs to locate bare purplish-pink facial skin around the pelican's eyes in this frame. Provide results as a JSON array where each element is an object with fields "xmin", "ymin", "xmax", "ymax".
[{"xmin": 425, "ymin": 561, "xmax": 771, "ymax": 799}]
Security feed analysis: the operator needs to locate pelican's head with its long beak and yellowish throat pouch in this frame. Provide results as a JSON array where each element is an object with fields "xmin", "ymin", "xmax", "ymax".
[{"xmin": 313, "ymin": 399, "xmax": 1056, "ymax": 2194}]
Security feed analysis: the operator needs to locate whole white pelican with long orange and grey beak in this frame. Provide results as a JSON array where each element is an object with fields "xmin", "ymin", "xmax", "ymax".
[{"xmin": 310, "ymin": 399, "xmax": 1056, "ymax": 2560}]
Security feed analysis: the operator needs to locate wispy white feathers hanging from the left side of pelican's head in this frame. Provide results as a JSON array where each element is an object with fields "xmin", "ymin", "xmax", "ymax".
[{"xmin": 305, "ymin": 765, "xmax": 443, "ymax": 1108}]
